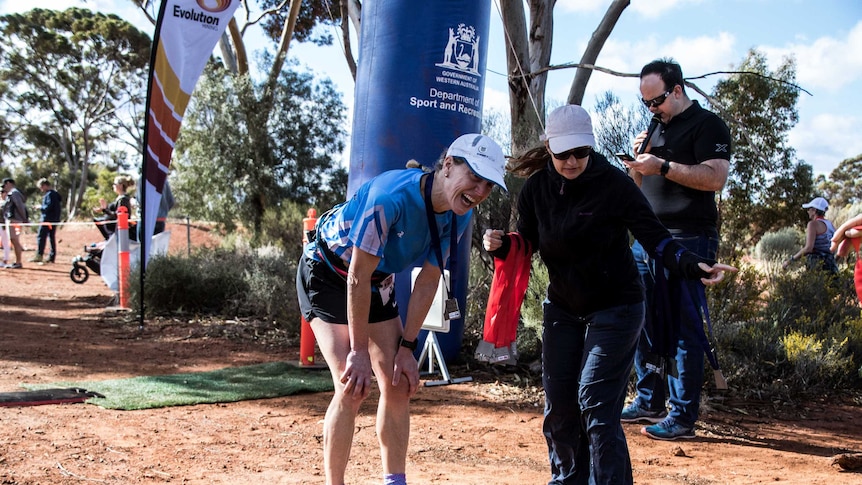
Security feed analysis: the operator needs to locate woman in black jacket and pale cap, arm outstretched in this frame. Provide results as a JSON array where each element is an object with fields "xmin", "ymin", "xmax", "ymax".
[{"xmin": 483, "ymin": 105, "xmax": 736, "ymax": 484}]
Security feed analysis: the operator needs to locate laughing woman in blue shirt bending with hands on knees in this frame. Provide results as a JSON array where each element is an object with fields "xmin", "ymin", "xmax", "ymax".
[{"xmin": 296, "ymin": 134, "xmax": 506, "ymax": 485}]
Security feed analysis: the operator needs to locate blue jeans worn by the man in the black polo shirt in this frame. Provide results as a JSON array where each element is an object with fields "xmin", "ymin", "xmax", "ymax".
[{"xmin": 632, "ymin": 234, "xmax": 718, "ymax": 428}]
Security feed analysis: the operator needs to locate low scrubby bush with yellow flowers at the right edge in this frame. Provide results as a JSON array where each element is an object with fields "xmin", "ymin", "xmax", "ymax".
[{"xmin": 710, "ymin": 266, "xmax": 862, "ymax": 399}]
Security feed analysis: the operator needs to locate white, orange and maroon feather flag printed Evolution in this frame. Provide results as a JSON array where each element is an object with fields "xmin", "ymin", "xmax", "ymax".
[{"xmin": 139, "ymin": 0, "xmax": 240, "ymax": 268}]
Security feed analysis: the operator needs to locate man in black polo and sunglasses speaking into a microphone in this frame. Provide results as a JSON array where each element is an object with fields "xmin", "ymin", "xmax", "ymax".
[{"xmin": 621, "ymin": 59, "xmax": 730, "ymax": 440}]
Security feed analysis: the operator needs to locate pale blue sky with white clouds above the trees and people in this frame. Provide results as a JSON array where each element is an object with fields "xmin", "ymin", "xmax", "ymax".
[{"xmin": 0, "ymin": 0, "xmax": 862, "ymax": 174}]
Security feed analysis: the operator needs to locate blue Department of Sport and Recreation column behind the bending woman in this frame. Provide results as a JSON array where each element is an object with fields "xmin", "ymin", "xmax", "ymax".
[{"xmin": 348, "ymin": 0, "xmax": 491, "ymax": 359}]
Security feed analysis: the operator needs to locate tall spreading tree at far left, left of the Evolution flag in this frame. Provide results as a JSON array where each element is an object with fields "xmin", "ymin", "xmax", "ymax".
[{"xmin": 0, "ymin": 8, "xmax": 150, "ymax": 217}]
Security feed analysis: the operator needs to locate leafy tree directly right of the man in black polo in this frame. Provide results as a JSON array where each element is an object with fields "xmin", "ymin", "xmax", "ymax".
[{"xmin": 710, "ymin": 50, "xmax": 814, "ymax": 249}]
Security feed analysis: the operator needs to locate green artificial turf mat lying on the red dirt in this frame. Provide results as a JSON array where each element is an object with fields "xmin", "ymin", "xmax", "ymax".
[{"xmin": 22, "ymin": 362, "xmax": 332, "ymax": 411}]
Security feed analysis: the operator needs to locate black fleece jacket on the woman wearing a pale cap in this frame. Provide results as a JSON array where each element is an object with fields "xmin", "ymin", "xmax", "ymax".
[{"xmin": 493, "ymin": 152, "xmax": 705, "ymax": 317}]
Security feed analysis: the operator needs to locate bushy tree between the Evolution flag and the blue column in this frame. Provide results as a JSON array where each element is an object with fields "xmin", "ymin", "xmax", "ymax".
[{"xmin": 171, "ymin": 64, "xmax": 347, "ymax": 237}]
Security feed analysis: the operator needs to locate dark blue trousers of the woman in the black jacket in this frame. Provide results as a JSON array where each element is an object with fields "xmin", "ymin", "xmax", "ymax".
[{"xmin": 542, "ymin": 300, "xmax": 645, "ymax": 485}]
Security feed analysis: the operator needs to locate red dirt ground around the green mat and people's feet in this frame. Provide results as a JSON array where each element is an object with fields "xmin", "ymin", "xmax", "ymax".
[{"xmin": 0, "ymin": 221, "xmax": 862, "ymax": 485}]
